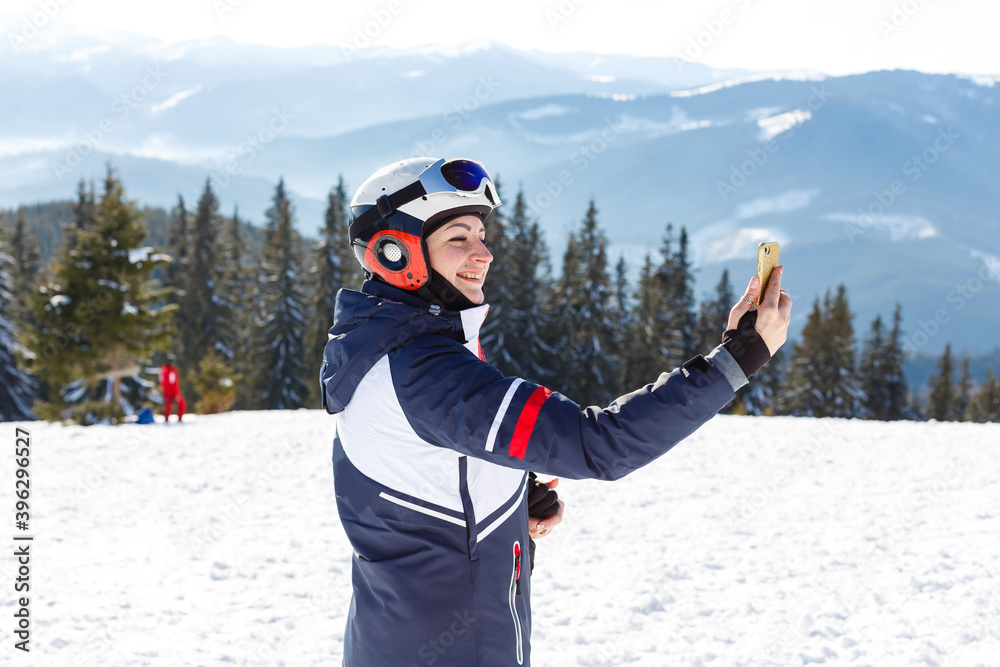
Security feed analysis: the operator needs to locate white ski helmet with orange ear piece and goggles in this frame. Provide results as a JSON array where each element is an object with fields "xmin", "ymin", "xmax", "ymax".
[{"xmin": 350, "ymin": 157, "xmax": 500, "ymax": 290}]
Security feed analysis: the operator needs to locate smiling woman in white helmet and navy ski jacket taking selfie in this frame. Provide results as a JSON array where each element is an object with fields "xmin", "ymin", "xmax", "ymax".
[{"xmin": 321, "ymin": 158, "xmax": 791, "ymax": 667}]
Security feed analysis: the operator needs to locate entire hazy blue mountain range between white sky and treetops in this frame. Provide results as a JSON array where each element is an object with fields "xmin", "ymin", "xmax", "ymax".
[{"xmin": 0, "ymin": 20, "xmax": 1000, "ymax": 352}]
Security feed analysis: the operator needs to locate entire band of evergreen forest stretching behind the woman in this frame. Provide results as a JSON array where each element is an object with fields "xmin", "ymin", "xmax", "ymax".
[{"xmin": 0, "ymin": 169, "xmax": 1000, "ymax": 423}]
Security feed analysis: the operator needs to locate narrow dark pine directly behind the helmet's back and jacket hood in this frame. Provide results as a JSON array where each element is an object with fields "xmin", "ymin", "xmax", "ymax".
[{"xmin": 307, "ymin": 176, "xmax": 362, "ymax": 405}]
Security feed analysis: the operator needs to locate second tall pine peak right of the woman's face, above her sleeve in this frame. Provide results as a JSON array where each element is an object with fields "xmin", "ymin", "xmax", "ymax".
[{"xmin": 556, "ymin": 201, "xmax": 620, "ymax": 404}]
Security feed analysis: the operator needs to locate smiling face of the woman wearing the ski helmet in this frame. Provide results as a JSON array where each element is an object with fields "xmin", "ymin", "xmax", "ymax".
[{"xmin": 427, "ymin": 215, "xmax": 493, "ymax": 304}]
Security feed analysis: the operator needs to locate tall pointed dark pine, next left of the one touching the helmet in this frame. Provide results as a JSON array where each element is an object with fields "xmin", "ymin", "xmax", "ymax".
[{"xmin": 254, "ymin": 179, "xmax": 313, "ymax": 410}]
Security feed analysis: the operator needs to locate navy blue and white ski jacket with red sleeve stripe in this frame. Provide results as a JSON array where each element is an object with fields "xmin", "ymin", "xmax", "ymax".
[{"xmin": 320, "ymin": 281, "xmax": 747, "ymax": 667}]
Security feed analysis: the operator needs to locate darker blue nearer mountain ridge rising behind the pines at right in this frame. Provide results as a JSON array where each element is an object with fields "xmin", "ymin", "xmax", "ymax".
[{"xmin": 201, "ymin": 72, "xmax": 1000, "ymax": 358}]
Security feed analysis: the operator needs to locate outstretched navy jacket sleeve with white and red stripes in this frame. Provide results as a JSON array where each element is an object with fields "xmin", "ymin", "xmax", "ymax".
[{"xmin": 390, "ymin": 336, "xmax": 746, "ymax": 480}]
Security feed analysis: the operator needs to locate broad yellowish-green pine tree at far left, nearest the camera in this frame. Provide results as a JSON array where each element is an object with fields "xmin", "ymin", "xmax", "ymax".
[{"xmin": 28, "ymin": 167, "xmax": 172, "ymax": 423}]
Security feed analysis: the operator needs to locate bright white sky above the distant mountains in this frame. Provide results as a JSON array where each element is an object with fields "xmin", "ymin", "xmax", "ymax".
[{"xmin": 7, "ymin": 0, "xmax": 1000, "ymax": 75}]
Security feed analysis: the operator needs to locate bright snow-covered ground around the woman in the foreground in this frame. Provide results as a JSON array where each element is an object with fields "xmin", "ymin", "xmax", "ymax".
[{"xmin": 0, "ymin": 411, "xmax": 1000, "ymax": 667}]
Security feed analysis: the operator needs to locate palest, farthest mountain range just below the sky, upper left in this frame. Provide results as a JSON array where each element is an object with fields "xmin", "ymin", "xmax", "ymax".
[{"xmin": 0, "ymin": 16, "xmax": 727, "ymax": 160}]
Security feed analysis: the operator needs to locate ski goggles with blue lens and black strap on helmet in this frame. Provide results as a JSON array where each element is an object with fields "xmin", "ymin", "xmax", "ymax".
[{"xmin": 350, "ymin": 158, "xmax": 500, "ymax": 238}]
